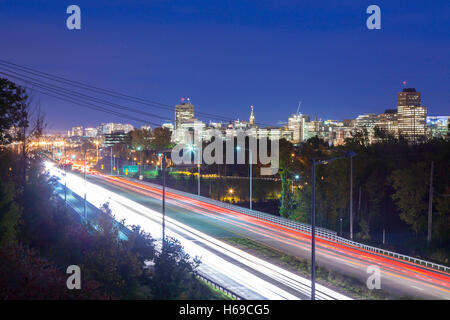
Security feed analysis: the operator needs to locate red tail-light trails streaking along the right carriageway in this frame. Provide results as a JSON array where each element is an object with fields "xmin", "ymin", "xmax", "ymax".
[{"xmin": 100, "ymin": 175, "xmax": 450, "ymax": 293}]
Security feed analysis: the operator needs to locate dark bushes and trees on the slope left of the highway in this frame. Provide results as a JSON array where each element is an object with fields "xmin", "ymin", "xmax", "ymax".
[{"xmin": 0, "ymin": 79, "xmax": 223, "ymax": 300}]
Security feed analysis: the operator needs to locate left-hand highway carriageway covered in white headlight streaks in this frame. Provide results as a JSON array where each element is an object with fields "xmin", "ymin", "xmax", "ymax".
[{"xmin": 47, "ymin": 163, "xmax": 349, "ymax": 300}]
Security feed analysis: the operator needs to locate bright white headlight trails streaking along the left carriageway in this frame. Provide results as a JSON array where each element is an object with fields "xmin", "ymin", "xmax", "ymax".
[{"xmin": 46, "ymin": 163, "xmax": 349, "ymax": 300}]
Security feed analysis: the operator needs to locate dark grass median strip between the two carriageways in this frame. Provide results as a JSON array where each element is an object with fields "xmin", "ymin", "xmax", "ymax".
[{"xmin": 225, "ymin": 238, "xmax": 418, "ymax": 300}]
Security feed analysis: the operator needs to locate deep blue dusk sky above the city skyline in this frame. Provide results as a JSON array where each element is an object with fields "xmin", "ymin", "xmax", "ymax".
[{"xmin": 0, "ymin": 0, "xmax": 450, "ymax": 130}]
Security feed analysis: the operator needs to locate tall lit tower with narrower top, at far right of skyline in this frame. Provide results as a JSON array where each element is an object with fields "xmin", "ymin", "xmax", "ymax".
[{"xmin": 397, "ymin": 88, "xmax": 427, "ymax": 143}]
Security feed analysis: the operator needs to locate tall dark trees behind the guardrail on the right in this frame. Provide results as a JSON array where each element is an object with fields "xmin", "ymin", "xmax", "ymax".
[{"xmin": 280, "ymin": 130, "xmax": 450, "ymax": 263}]
